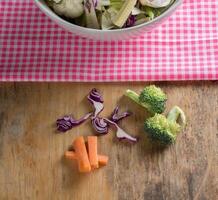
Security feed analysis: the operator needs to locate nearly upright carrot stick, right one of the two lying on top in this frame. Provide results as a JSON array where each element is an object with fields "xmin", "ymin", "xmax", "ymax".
[{"xmin": 88, "ymin": 136, "xmax": 98, "ymax": 169}]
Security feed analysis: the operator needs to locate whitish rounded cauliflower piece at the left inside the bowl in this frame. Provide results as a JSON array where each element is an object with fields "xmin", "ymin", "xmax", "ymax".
[{"xmin": 53, "ymin": 0, "xmax": 84, "ymax": 18}]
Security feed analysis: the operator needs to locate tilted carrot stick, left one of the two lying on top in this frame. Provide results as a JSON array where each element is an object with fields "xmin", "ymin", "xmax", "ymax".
[{"xmin": 73, "ymin": 136, "xmax": 91, "ymax": 172}]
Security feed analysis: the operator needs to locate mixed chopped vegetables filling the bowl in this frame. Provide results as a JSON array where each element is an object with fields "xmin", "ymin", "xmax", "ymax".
[{"xmin": 46, "ymin": 0, "xmax": 175, "ymax": 30}]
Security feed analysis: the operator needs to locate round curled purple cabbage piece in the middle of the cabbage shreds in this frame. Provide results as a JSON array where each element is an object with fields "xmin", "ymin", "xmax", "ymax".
[{"xmin": 92, "ymin": 117, "xmax": 109, "ymax": 135}]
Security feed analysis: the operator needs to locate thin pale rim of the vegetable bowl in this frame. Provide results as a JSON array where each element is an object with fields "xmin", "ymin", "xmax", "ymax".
[{"xmin": 34, "ymin": 0, "xmax": 182, "ymax": 33}]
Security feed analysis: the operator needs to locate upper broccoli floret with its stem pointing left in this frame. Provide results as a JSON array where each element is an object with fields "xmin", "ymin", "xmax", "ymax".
[{"xmin": 125, "ymin": 85, "xmax": 167, "ymax": 114}]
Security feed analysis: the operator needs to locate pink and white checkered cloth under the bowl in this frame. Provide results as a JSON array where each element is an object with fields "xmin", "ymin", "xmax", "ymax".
[{"xmin": 0, "ymin": 0, "xmax": 218, "ymax": 82}]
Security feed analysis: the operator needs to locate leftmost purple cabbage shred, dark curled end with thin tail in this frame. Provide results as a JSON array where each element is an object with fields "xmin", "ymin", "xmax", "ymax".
[{"xmin": 56, "ymin": 113, "xmax": 92, "ymax": 132}]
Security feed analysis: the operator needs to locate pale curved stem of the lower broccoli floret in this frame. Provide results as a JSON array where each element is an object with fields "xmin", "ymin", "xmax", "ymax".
[{"xmin": 167, "ymin": 106, "xmax": 186, "ymax": 126}]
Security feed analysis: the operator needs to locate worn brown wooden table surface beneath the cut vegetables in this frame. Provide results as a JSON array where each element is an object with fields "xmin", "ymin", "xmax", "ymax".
[{"xmin": 0, "ymin": 82, "xmax": 218, "ymax": 200}]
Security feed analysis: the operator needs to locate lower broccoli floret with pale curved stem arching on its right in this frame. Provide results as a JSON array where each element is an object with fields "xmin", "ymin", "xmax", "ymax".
[{"xmin": 144, "ymin": 106, "xmax": 186, "ymax": 145}]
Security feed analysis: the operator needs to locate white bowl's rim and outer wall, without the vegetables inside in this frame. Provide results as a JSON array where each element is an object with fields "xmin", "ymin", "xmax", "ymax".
[{"xmin": 34, "ymin": 0, "xmax": 182, "ymax": 41}]
